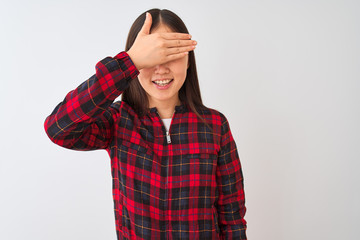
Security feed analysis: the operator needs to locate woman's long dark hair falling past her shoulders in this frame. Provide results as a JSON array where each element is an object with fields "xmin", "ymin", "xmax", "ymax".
[{"xmin": 121, "ymin": 8, "xmax": 211, "ymax": 129}]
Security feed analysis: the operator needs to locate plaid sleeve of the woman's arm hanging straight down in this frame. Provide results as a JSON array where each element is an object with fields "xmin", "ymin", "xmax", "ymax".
[{"xmin": 216, "ymin": 116, "xmax": 247, "ymax": 240}]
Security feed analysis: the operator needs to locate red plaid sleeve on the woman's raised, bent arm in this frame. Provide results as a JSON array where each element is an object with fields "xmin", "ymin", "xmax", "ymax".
[{"xmin": 44, "ymin": 51, "xmax": 139, "ymax": 150}]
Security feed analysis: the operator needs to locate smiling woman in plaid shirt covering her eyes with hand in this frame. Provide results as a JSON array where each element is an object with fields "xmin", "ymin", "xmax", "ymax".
[{"xmin": 44, "ymin": 9, "xmax": 246, "ymax": 239}]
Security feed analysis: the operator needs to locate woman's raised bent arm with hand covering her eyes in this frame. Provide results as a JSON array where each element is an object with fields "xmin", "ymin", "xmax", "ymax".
[{"xmin": 44, "ymin": 13, "xmax": 197, "ymax": 150}]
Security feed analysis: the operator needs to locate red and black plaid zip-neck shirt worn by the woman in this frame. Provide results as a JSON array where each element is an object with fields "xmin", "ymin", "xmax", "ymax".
[{"xmin": 44, "ymin": 51, "xmax": 246, "ymax": 240}]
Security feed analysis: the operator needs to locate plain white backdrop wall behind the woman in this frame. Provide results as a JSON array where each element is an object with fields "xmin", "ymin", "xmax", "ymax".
[{"xmin": 0, "ymin": 0, "xmax": 360, "ymax": 240}]
